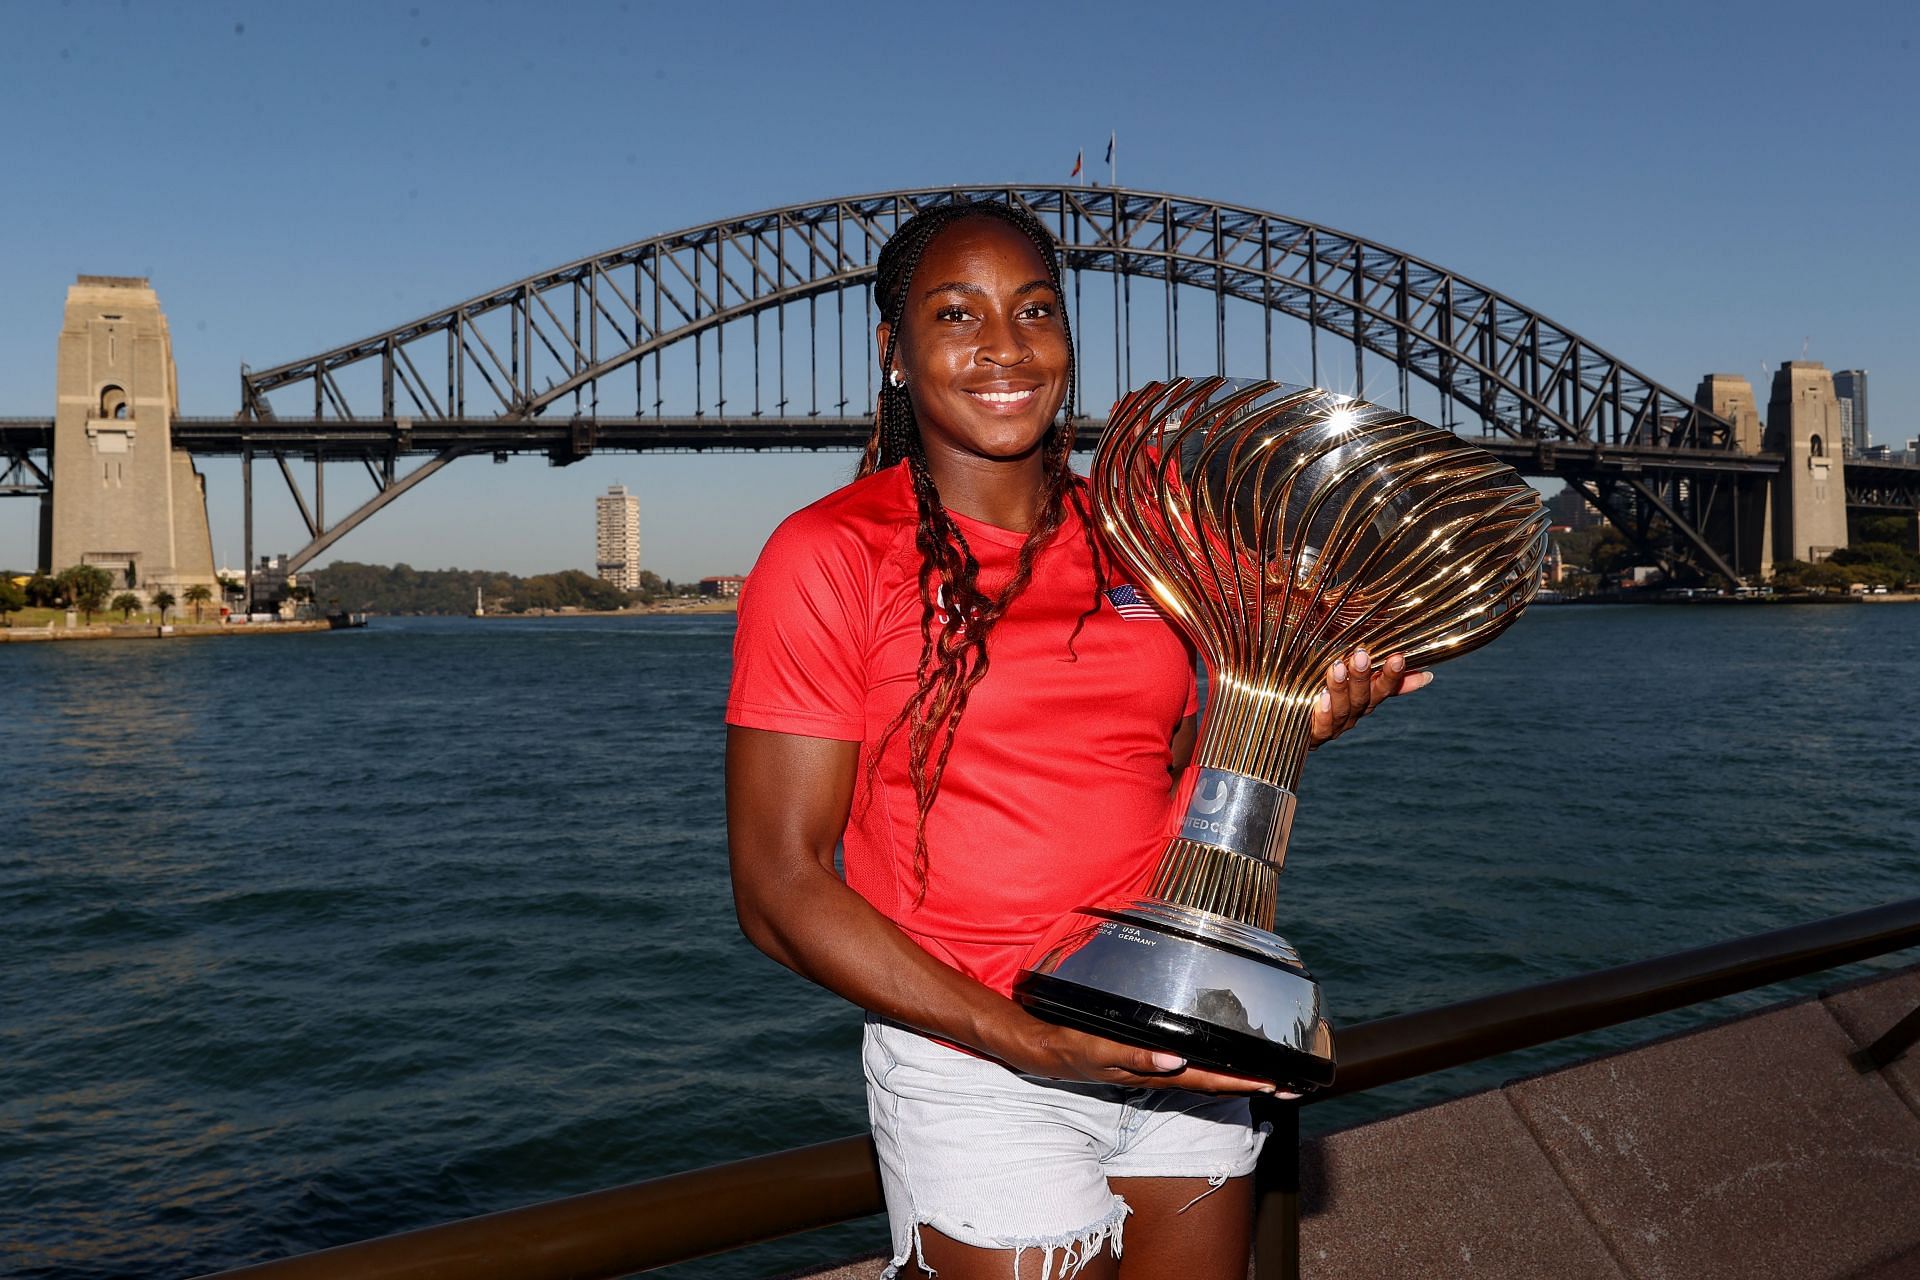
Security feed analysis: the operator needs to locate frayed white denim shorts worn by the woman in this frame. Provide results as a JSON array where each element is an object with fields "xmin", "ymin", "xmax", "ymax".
[{"xmin": 860, "ymin": 1015, "xmax": 1265, "ymax": 1280}]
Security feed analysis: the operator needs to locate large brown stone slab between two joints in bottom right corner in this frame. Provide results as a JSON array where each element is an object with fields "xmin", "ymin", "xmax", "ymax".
[{"xmin": 1507, "ymin": 971, "xmax": 1920, "ymax": 1280}]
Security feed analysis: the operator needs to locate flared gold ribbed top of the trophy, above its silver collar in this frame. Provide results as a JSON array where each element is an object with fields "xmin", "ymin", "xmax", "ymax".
[{"xmin": 1091, "ymin": 378, "xmax": 1548, "ymax": 791}]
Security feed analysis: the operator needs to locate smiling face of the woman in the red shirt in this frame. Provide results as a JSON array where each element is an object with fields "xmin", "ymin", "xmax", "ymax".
[{"xmin": 879, "ymin": 217, "xmax": 1069, "ymax": 470}]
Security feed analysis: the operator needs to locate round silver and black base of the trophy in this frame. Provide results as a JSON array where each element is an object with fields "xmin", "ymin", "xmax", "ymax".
[{"xmin": 1014, "ymin": 898, "xmax": 1334, "ymax": 1092}]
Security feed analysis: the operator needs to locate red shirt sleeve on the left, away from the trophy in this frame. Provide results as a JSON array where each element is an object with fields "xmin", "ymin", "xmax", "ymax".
[{"xmin": 726, "ymin": 510, "xmax": 874, "ymax": 743}]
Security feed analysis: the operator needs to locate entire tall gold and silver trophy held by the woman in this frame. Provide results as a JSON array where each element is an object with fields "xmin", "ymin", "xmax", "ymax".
[{"xmin": 1014, "ymin": 378, "xmax": 1548, "ymax": 1092}]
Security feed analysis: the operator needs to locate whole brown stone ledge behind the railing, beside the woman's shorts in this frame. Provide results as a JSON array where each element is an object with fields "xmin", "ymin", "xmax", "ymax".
[{"xmin": 771, "ymin": 965, "xmax": 1920, "ymax": 1280}]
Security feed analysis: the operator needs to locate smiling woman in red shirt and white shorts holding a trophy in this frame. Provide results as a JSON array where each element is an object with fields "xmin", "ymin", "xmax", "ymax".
[{"xmin": 728, "ymin": 203, "xmax": 1427, "ymax": 1280}]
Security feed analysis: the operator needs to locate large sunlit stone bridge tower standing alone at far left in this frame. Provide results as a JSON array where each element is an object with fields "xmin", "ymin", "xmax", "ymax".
[{"xmin": 48, "ymin": 276, "xmax": 215, "ymax": 599}]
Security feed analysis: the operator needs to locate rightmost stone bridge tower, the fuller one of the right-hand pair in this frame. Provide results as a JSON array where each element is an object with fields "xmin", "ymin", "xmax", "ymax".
[{"xmin": 1766, "ymin": 361, "xmax": 1847, "ymax": 560}]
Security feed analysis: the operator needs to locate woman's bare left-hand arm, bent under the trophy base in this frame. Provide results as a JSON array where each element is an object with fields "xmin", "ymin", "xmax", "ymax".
[{"xmin": 726, "ymin": 727, "xmax": 1271, "ymax": 1092}]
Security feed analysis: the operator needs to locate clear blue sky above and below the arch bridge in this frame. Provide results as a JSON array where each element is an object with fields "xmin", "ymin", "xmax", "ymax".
[{"xmin": 0, "ymin": 0, "xmax": 1920, "ymax": 578}]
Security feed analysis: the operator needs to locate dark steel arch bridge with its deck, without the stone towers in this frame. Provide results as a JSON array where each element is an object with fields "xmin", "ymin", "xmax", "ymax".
[{"xmin": 0, "ymin": 186, "xmax": 1920, "ymax": 581}]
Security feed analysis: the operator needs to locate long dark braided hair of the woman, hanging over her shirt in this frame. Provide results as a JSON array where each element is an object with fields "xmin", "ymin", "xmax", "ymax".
[{"xmin": 858, "ymin": 201, "xmax": 1104, "ymax": 902}]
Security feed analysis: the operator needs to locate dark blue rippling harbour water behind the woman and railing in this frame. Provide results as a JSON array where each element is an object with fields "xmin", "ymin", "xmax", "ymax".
[{"xmin": 0, "ymin": 606, "xmax": 1920, "ymax": 1280}]
